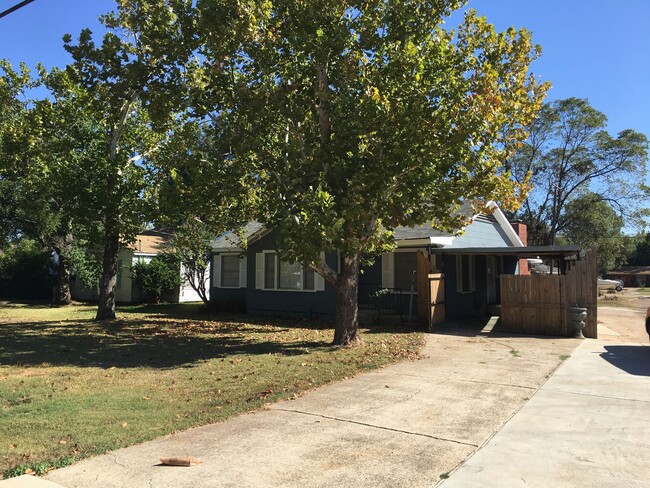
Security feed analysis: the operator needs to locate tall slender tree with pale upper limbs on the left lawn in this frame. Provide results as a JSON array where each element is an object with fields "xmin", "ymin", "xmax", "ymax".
[{"xmin": 64, "ymin": 0, "xmax": 195, "ymax": 320}]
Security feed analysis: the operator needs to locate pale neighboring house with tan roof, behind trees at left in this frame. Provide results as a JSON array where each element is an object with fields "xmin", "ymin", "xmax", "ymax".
[{"xmin": 72, "ymin": 230, "xmax": 209, "ymax": 303}]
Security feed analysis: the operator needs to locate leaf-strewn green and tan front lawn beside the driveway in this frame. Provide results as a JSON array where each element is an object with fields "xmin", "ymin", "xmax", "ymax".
[{"xmin": 0, "ymin": 305, "xmax": 423, "ymax": 477}]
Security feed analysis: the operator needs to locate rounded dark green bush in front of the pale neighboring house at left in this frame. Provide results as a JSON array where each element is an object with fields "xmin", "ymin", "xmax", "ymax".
[{"xmin": 131, "ymin": 255, "xmax": 181, "ymax": 303}]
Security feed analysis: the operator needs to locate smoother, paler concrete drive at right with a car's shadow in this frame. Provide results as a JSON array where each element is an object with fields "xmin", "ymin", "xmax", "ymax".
[{"xmin": 440, "ymin": 340, "xmax": 650, "ymax": 488}]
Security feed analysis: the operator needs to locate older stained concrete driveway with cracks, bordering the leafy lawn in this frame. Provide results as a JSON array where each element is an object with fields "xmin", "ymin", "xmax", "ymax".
[{"xmin": 40, "ymin": 329, "xmax": 579, "ymax": 488}]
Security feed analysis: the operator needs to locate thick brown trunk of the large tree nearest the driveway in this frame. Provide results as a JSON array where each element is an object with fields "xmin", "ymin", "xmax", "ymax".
[{"xmin": 334, "ymin": 255, "xmax": 361, "ymax": 346}]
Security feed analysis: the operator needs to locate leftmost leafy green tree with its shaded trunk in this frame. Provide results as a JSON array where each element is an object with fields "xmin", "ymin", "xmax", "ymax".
[{"xmin": 0, "ymin": 63, "xmax": 104, "ymax": 305}]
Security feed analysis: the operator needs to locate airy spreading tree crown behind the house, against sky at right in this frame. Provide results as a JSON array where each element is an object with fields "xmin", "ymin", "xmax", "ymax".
[{"xmin": 508, "ymin": 98, "xmax": 648, "ymax": 245}]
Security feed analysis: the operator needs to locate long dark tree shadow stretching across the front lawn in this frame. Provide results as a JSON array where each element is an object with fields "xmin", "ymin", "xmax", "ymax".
[{"xmin": 0, "ymin": 319, "xmax": 329, "ymax": 368}]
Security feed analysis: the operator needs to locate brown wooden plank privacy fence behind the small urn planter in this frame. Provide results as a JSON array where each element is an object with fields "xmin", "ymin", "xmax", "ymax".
[{"xmin": 500, "ymin": 251, "xmax": 598, "ymax": 339}]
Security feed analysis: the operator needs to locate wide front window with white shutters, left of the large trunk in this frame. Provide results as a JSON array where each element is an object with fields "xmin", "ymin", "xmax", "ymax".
[{"xmin": 257, "ymin": 252, "xmax": 322, "ymax": 291}]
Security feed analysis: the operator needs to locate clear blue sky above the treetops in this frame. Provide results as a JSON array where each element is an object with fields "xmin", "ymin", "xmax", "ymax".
[{"xmin": 0, "ymin": 0, "xmax": 650, "ymax": 141}]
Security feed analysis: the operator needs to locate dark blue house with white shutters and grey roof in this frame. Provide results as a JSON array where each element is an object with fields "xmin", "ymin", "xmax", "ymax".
[{"xmin": 211, "ymin": 205, "xmax": 528, "ymax": 319}]
